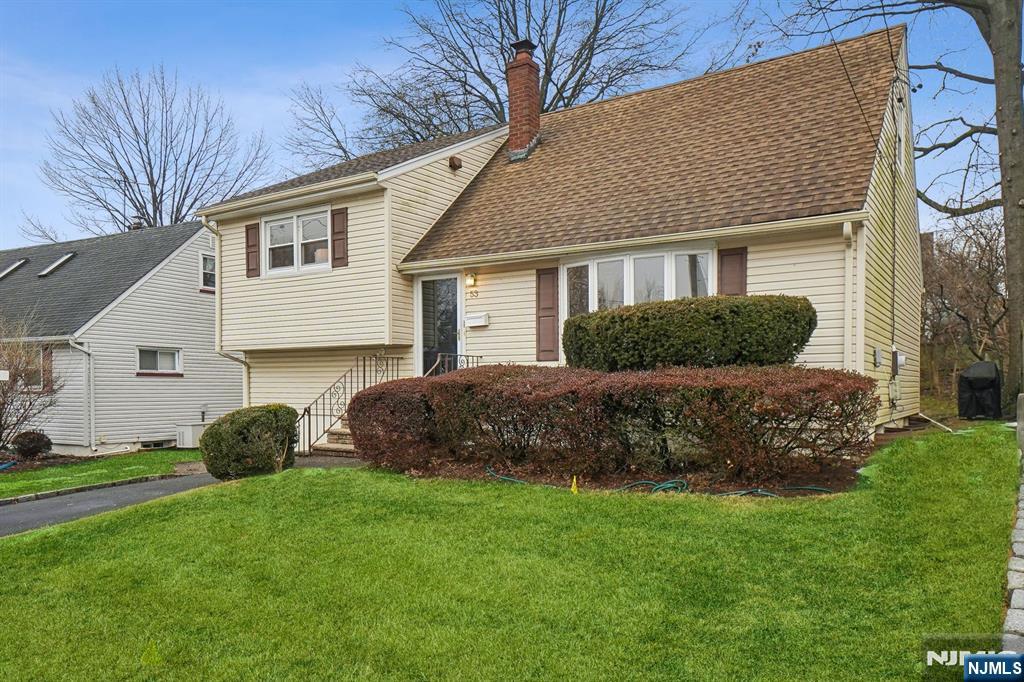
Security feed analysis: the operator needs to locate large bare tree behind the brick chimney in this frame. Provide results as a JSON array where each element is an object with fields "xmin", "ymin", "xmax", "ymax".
[{"xmin": 287, "ymin": 0, "xmax": 763, "ymax": 167}]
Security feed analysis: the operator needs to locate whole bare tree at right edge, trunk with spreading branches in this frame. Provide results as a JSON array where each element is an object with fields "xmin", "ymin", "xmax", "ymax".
[{"xmin": 786, "ymin": 0, "xmax": 1024, "ymax": 395}]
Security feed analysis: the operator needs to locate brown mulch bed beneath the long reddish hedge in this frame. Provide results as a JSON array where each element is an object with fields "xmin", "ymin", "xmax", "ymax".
[{"xmin": 395, "ymin": 459, "xmax": 864, "ymax": 497}]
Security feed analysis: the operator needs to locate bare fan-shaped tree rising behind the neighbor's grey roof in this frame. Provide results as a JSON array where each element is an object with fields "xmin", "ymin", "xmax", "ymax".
[{"xmin": 41, "ymin": 67, "xmax": 268, "ymax": 235}]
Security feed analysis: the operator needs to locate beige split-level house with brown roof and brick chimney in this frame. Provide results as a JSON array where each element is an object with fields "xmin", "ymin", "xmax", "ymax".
[{"xmin": 202, "ymin": 27, "xmax": 922, "ymax": 450}]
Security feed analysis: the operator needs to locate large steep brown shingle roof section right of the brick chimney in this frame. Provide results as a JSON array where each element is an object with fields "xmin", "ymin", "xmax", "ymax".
[{"xmin": 406, "ymin": 27, "xmax": 905, "ymax": 262}]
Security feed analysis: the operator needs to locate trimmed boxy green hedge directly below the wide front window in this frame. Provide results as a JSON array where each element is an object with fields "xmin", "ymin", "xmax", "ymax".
[{"xmin": 562, "ymin": 296, "xmax": 818, "ymax": 372}]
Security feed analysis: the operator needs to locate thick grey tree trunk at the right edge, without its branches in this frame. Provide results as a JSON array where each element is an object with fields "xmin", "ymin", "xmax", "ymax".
[{"xmin": 968, "ymin": 0, "xmax": 1024, "ymax": 404}]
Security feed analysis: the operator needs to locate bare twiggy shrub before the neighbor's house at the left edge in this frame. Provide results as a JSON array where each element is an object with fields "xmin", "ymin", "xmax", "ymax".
[{"xmin": 0, "ymin": 316, "xmax": 62, "ymax": 447}]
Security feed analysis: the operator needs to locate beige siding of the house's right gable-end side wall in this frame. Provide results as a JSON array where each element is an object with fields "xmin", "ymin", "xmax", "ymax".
[{"xmin": 861, "ymin": 46, "xmax": 922, "ymax": 422}]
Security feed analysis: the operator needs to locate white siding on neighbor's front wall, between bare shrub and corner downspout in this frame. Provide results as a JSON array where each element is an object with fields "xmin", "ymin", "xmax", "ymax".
[{"xmin": 31, "ymin": 345, "xmax": 89, "ymax": 453}]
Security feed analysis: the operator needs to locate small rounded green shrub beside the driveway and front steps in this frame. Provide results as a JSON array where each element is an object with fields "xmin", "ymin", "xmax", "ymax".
[{"xmin": 199, "ymin": 404, "xmax": 299, "ymax": 480}]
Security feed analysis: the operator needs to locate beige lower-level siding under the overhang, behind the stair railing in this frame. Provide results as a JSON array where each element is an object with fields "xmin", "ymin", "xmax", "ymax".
[{"xmin": 246, "ymin": 348, "xmax": 413, "ymax": 412}]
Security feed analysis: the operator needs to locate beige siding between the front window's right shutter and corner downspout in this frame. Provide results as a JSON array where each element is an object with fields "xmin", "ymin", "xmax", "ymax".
[{"xmin": 719, "ymin": 226, "xmax": 847, "ymax": 370}]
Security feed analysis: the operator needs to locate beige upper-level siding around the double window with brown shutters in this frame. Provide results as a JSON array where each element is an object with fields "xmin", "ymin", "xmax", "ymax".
[{"xmin": 220, "ymin": 190, "xmax": 386, "ymax": 351}]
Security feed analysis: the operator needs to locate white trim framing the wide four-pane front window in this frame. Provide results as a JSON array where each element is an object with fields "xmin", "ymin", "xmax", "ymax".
[{"xmin": 558, "ymin": 245, "xmax": 718, "ymax": 322}]
